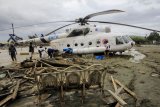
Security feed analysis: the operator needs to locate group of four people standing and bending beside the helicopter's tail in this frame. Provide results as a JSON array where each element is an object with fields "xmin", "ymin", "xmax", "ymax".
[{"xmin": 9, "ymin": 42, "xmax": 55, "ymax": 61}]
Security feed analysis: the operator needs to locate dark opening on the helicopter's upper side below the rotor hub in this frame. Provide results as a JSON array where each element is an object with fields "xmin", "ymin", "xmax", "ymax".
[{"xmin": 67, "ymin": 28, "xmax": 90, "ymax": 37}]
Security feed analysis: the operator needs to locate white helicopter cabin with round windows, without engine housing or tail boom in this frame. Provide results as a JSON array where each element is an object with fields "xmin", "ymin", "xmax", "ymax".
[{"xmin": 50, "ymin": 32, "xmax": 134, "ymax": 54}]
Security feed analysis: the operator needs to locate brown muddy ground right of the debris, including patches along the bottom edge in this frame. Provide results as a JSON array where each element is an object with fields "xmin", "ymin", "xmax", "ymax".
[{"xmin": 1, "ymin": 45, "xmax": 160, "ymax": 107}]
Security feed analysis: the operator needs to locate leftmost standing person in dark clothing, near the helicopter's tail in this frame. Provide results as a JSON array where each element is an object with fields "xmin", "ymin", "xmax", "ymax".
[{"xmin": 9, "ymin": 44, "xmax": 17, "ymax": 61}]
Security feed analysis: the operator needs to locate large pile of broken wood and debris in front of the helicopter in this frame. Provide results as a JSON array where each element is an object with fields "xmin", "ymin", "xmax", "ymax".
[{"xmin": 0, "ymin": 58, "xmax": 136, "ymax": 107}]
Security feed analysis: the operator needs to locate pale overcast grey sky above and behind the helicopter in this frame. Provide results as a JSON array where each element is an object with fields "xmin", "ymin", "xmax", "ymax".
[{"xmin": 0, "ymin": 0, "xmax": 160, "ymax": 41}]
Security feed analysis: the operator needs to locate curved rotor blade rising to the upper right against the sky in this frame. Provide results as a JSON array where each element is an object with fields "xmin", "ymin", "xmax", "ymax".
[{"xmin": 84, "ymin": 9, "xmax": 124, "ymax": 20}]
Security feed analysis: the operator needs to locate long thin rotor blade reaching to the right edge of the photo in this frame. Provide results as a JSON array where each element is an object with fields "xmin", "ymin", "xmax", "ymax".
[{"xmin": 88, "ymin": 21, "xmax": 160, "ymax": 32}]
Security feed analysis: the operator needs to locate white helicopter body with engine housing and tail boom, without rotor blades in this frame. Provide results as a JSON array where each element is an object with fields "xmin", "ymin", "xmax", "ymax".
[{"xmin": 19, "ymin": 25, "xmax": 134, "ymax": 54}]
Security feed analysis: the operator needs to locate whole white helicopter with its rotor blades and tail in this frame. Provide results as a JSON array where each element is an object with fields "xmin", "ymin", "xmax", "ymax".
[{"xmin": 8, "ymin": 9, "xmax": 160, "ymax": 54}]
